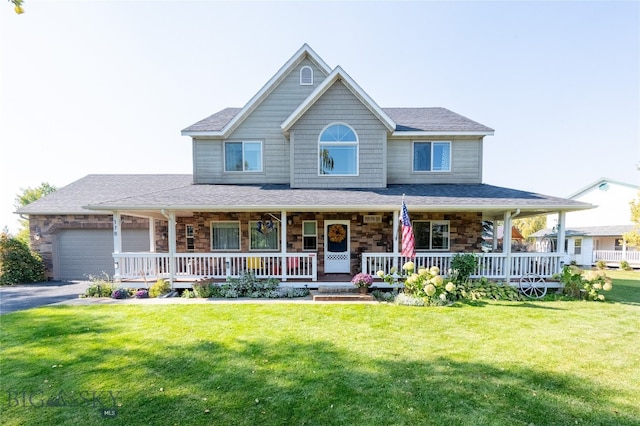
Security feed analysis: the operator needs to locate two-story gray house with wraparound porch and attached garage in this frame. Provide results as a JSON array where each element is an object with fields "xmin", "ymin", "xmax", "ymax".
[{"xmin": 18, "ymin": 44, "xmax": 592, "ymax": 286}]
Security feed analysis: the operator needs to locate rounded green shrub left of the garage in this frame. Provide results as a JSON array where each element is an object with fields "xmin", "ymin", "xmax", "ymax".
[{"xmin": 0, "ymin": 233, "xmax": 45, "ymax": 285}]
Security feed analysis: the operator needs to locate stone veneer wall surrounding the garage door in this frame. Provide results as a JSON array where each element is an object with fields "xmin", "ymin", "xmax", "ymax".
[{"xmin": 29, "ymin": 215, "xmax": 150, "ymax": 279}]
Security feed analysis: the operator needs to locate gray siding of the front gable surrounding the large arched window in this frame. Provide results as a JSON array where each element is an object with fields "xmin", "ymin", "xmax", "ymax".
[{"xmin": 291, "ymin": 81, "xmax": 387, "ymax": 188}]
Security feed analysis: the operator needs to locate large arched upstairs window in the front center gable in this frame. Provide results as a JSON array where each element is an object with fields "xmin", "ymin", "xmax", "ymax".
[{"xmin": 318, "ymin": 123, "xmax": 358, "ymax": 176}]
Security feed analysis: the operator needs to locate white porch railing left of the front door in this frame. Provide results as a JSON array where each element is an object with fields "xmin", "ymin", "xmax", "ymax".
[{"xmin": 113, "ymin": 252, "xmax": 318, "ymax": 281}]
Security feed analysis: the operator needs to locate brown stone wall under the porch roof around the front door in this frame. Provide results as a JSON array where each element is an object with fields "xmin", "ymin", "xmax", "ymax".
[{"xmin": 172, "ymin": 212, "xmax": 482, "ymax": 274}]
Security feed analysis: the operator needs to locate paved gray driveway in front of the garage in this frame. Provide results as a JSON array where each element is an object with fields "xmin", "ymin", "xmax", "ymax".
[{"xmin": 0, "ymin": 281, "xmax": 89, "ymax": 314}]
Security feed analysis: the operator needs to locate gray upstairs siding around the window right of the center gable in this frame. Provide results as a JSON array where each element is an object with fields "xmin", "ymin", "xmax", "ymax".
[{"xmin": 387, "ymin": 137, "xmax": 482, "ymax": 184}]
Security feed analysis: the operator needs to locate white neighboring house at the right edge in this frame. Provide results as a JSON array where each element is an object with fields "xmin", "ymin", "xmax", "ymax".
[{"xmin": 532, "ymin": 178, "xmax": 640, "ymax": 267}]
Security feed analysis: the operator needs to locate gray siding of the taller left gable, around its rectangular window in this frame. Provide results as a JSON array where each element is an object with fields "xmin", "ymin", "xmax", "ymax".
[{"xmin": 193, "ymin": 59, "xmax": 326, "ymax": 184}]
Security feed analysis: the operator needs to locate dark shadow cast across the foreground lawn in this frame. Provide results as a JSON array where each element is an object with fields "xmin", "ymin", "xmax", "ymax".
[{"xmin": 0, "ymin": 305, "xmax": 638, "ymax": 426}]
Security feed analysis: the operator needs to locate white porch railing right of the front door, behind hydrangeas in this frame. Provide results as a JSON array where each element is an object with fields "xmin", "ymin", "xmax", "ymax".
[{"xmin": 362, "ymin": 253, "xmax": 565, "ymax": 280}]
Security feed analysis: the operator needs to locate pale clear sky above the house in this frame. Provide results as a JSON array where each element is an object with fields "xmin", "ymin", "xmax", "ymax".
[{"xmin": 0, "ymin": 0, "xmax": 640, "ymax": 232}]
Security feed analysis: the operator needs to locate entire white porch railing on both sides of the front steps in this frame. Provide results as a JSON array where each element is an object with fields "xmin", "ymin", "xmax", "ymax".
[{"xmin": 114, "ymin": 253, "xmax": 564, "ymax": 288}]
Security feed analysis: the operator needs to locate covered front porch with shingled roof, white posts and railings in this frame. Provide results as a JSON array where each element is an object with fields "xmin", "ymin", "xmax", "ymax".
[{"xmin": 89, "ymin": 185, "xmax": 590, "ymax": 287}]
